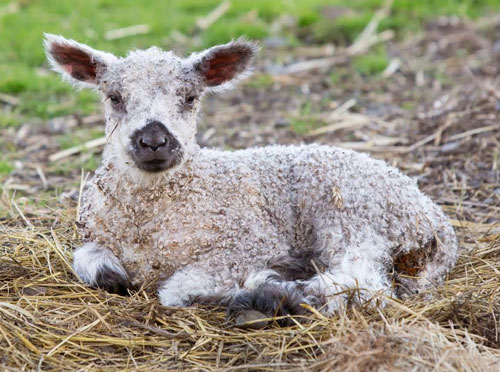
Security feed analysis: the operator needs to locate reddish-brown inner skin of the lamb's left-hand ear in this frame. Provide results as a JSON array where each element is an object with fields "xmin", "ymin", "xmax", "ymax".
[{"xmin": 50, "ymin": 44, "xmax": 97, "ymax": 82}]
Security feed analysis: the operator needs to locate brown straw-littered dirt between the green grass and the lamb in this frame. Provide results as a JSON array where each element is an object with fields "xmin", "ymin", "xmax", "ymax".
[{"xmin": 3, "ymin": 19, "xmax": 500, "ymax": 222}]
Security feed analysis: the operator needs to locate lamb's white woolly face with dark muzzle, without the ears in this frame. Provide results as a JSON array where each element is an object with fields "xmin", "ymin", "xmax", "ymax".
[{"xmin": 99, "ymin": 48, "xmax": 205, "ymax": 172}]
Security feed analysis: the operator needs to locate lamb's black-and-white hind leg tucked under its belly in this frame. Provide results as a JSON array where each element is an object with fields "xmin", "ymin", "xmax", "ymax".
[{"xmin": 228, "ymin": 246, "xmax": 392, "ymax": 328}]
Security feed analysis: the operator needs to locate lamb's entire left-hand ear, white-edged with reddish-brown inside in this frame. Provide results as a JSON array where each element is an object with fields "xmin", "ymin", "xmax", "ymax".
[{"xmin": 44, "ymin": 34, "xmax": 116, "ymax": 87}]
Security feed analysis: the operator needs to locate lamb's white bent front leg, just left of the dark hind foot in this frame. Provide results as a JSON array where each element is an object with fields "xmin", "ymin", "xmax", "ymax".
[{"xmin": 158, "ymin": 266, "xmax": 228, "ymax": 307}]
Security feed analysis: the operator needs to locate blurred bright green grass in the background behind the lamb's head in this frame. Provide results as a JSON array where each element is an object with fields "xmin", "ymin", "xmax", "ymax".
[{"xmin": 0, "ymin": 0, "xmax": 500, "ymax": 127}]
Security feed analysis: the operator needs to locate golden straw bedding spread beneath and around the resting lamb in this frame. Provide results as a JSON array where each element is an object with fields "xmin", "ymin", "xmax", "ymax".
[{"xmin": 0, "ymin": 211, "xmax": 500, "ymax": 371}]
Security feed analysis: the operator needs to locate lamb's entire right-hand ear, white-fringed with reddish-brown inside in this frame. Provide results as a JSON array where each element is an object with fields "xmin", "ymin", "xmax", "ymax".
[{"xmin": 188, "ymin": 39, "xmax": 259, "ymax": 91}]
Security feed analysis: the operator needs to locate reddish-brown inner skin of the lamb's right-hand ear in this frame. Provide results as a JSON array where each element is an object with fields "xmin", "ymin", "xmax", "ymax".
[{"xmin": 203, "ymin": 47, "xmax": 252, "ymax": 86}]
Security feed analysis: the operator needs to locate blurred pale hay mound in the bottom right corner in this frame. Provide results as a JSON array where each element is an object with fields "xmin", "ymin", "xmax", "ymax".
[{"xmin": 314, "ymin": 323, "xmax": 498, "ymax": 372}]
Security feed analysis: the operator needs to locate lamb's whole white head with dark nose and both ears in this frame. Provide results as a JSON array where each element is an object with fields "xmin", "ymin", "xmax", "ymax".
[{"xmin": 45, "ymin": 35, "xmax": 257, "ymax": 173}]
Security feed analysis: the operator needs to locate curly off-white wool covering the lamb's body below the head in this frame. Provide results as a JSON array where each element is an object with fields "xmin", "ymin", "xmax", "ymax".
[{"xmin": 80, "ymin": 145, "xmax": 457, "ymax": 298}]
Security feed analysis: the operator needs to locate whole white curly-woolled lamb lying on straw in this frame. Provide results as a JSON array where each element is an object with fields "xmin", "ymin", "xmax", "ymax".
[{"xmin": 45, "ymin": 35, "xmax": 458, "ymax": 325}]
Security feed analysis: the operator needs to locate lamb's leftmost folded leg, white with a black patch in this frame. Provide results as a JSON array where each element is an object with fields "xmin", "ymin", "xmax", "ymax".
[{"xmin": 73, "ymin": 243, "xmax": 131, "ymax": 295}]
